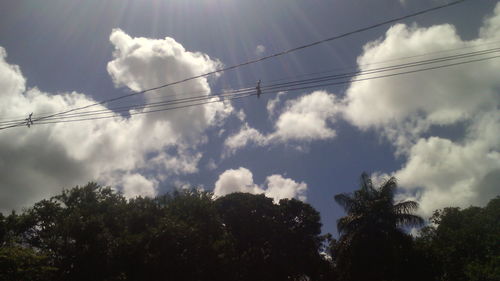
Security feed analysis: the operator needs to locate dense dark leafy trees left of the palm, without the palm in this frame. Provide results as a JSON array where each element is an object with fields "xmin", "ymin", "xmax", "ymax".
[{"xmin": 0, "ymin": 183, "xmax": 326, "ymax": 281}]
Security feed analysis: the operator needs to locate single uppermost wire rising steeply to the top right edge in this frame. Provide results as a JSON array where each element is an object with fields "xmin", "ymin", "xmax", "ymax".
[{"xmin": 0, "ymin": 0, "xmax": 468, "ymax": 130}]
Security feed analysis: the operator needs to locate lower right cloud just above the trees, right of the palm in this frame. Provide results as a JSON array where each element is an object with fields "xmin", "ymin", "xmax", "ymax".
[{"xmin": 395, "ymin": 112, "xmax": 500, "ymax": 215}]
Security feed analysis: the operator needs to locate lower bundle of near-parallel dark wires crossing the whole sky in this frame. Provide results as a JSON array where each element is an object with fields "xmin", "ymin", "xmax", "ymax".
[{"xmin": 0, "ymin": 48, "xmax": 500, "ymax": 129}]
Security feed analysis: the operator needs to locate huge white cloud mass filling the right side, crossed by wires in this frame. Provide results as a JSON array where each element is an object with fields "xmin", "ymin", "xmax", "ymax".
[{"xmin": 342, "ymin": 4, "xmax": 500, "ymax": 215}]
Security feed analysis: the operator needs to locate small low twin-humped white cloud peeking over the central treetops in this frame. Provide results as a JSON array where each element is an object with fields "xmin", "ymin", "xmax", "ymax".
[{"xmin": 214, "ymin": 167, "xmax": 307, "ymax": 203}]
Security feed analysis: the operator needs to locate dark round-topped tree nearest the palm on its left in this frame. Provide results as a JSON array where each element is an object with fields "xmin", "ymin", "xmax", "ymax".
[{"xmin": 215, "ymin": 193, "xmax": 324, "ymax": 281}]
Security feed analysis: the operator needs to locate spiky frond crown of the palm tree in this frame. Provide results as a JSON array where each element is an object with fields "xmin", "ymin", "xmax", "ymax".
[{"xmin": 334, "ymin": 173, "xmax": 424, "ymax": 237}]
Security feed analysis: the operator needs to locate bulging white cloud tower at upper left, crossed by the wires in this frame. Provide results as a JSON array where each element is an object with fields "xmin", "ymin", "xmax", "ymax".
[{"xmin": 108, "ymin": 29, "xmax": 232, "ymax": 141}]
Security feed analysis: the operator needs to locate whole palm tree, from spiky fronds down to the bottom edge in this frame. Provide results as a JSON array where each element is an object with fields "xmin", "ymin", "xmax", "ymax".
[{"xmin": 332, "ymin": 173, "xmax": 423, "ymax": 281}]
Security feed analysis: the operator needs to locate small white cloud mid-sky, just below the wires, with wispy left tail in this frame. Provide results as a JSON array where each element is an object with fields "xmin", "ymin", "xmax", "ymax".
[{"xmin": 224, "ymin": 91, "xmax": 339, "ymax": 154}]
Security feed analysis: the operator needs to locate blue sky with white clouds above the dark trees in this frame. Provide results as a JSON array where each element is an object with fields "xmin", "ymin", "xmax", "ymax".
[{"xmin": 0, "ymin": 0, "xmax": 500, "ymax": 235}]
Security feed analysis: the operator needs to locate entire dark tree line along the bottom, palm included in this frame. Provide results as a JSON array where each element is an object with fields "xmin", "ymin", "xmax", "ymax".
[{"xmin": 0, "ymin": 174, "xmax": 500, "ymax": 281}]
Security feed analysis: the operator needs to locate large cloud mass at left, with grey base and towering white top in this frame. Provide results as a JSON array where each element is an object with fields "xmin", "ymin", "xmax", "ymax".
[{"xmin": 0, "ymin": 30, "xmax": 232, "ymax": 211}]
